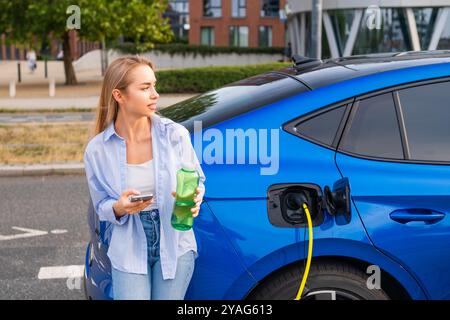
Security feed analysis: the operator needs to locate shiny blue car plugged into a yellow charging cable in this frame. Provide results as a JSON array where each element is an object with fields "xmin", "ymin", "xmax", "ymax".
[{"xmin": 85, "ymin": 51, "xmax": 450, "ymax": 300}]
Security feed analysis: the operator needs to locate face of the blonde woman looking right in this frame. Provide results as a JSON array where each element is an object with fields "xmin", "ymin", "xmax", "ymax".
[{"xmin": 119, "ymin": 65, "xmax": 159, "ymax": 116}]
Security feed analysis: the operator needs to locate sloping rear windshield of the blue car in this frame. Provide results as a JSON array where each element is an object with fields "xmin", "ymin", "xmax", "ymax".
[{"xmin": 159, "ymin": 72, "xmax": 308, "ymax": 131}]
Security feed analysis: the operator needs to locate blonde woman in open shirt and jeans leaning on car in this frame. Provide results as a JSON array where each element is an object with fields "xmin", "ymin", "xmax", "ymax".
[{"xmin": 84, "ymin": 56, "xmax": 205, "ymax": 300}]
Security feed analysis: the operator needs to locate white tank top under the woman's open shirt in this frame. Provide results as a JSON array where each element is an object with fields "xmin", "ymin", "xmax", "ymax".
[{"xmin": 127, "ymin": 159, "xmax": 158, "ymax": 211}]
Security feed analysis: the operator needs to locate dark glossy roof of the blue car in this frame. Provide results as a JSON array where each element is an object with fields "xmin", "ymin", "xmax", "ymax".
[{"xmin": 277, "ymin": 50, "xmax": 450, "ymax": 90}]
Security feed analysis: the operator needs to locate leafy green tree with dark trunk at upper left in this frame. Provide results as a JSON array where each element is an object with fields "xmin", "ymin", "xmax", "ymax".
[{"xmin": 0, "ymin": 0, "xmax": 173, "ymax": 85}]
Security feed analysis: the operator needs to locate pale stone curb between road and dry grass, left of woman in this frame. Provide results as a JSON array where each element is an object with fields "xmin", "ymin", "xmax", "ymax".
[{"xmin": 0, "ymin": 163, "xmax": 85, "ymax": 177}]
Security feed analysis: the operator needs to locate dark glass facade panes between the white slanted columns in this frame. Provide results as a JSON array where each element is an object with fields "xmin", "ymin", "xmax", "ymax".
[{"xmin": 294, "ymin": 7, "xmax": 450, "ymax": 58}]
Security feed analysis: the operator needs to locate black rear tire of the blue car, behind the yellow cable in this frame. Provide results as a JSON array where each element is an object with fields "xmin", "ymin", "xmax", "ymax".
[{"xmin": 247, "ymin": 259, "xmax": 389, "ymax": 300}]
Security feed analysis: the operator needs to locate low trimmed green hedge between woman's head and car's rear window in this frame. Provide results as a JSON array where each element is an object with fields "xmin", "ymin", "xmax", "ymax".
[{"xmin": 156, "ymin": 62, "xmax": 290, "ymax": 93}]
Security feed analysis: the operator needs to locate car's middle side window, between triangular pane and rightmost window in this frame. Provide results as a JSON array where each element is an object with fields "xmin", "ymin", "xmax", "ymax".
[{"xmin": 339, "ymin": 93, "xmax": 403, "ymax": 159}]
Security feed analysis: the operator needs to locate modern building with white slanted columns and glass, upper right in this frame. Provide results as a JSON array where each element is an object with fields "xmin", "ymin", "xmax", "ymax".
[{"xmin": 286, "ymin": 0, "xmax": 450, "ymax": 58}]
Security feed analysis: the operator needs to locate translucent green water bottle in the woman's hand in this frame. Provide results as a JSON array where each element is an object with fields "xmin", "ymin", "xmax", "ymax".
[{"xmin": 171, "ymin": 168, "xmax": 200, "ymax": 231}]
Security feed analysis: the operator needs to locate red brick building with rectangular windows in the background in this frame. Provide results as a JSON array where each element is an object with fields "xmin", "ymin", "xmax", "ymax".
[{"xmin": 189, "ymin": 0, "xmax": 286, "ymax": 48}]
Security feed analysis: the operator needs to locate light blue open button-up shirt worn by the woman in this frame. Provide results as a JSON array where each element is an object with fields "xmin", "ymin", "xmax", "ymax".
[{"xmin": 84, "ymin": 114, "xmax": 205, "ymax": 279}]
